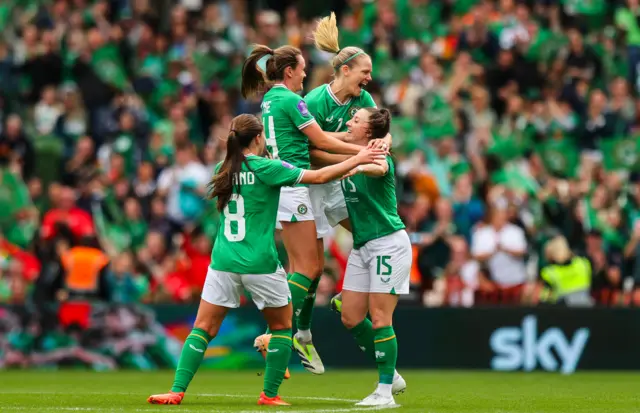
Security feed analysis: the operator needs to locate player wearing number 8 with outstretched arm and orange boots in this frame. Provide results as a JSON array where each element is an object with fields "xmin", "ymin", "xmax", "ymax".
[{"xmin": 148, "ymin": 115, "xmax": 384, "ymax": 405}]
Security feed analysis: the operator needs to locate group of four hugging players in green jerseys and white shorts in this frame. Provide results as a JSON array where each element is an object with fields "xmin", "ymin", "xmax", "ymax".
[{"xmin": 148, "ymin": 13, "xmax": 412, "ymax": 406}]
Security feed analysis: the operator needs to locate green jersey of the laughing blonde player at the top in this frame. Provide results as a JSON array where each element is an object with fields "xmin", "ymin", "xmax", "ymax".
[{"xmin": 304, "ymin": 84, "xmax": 376, "ymax": 132}]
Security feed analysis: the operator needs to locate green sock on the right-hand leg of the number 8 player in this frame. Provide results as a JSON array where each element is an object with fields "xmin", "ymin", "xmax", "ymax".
[{"xmin": 264, "ymin": 329, "xmax": 292, "ymax": 397}]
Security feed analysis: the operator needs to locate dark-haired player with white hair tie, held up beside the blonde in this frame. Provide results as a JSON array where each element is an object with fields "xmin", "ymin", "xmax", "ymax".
[{"xmin": 242, "ymin": 45, "xmax": 370, "ymax": 374}]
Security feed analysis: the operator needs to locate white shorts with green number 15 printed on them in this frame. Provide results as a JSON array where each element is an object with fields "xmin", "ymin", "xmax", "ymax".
[{"xmin": 342, "ymin": 230, "xmax": 413, "ymax": 295}]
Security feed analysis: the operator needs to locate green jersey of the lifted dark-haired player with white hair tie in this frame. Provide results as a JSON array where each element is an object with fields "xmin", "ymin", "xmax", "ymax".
[{"xmin": 261, "ymin": 84, "xmax": 316, "ymax": 169}]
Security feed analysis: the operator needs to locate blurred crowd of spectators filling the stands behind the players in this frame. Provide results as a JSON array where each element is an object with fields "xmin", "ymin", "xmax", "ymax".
[{"xmin": 0, "ymin": 0, "xmax": 640, "ymax": 306}]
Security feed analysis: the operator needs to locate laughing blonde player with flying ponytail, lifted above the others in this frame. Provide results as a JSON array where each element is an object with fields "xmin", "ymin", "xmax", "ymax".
[{"xmin": 293, "ymin": 13, "xmax": 391, "ymax": 372}]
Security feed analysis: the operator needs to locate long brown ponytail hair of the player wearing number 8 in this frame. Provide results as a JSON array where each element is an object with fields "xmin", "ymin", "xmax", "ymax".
[{"xmin": 208, "ymin": 114, "xmax": 262, "ymax": 212}]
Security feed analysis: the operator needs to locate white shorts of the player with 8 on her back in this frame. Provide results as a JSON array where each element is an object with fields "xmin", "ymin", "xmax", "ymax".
[{"xmin": 202, "ymin": 267, "xmax": 291, "ymax": 310}]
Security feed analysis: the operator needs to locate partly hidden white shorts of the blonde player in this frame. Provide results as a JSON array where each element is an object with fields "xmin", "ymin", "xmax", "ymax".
[{"xmin": 309, "ymin": 181, "xmax": 349, "ymax": 239}]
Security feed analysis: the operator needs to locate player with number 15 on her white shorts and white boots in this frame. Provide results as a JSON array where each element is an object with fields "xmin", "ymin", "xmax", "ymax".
[{"xmin": 324, "ymin": 108, "xmax": 412, "ymax": 406}]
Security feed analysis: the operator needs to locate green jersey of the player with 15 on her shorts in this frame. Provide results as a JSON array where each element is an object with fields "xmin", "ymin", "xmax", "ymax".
[{"xmin": 342, "ymin": 156, "xmax": 405, "ymax": 249}]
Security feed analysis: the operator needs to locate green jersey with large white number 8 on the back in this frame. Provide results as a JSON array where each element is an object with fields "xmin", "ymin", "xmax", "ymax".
[{"xmin": 211, "ymin": 155, "xmax": 304, "ymax": 274}]
